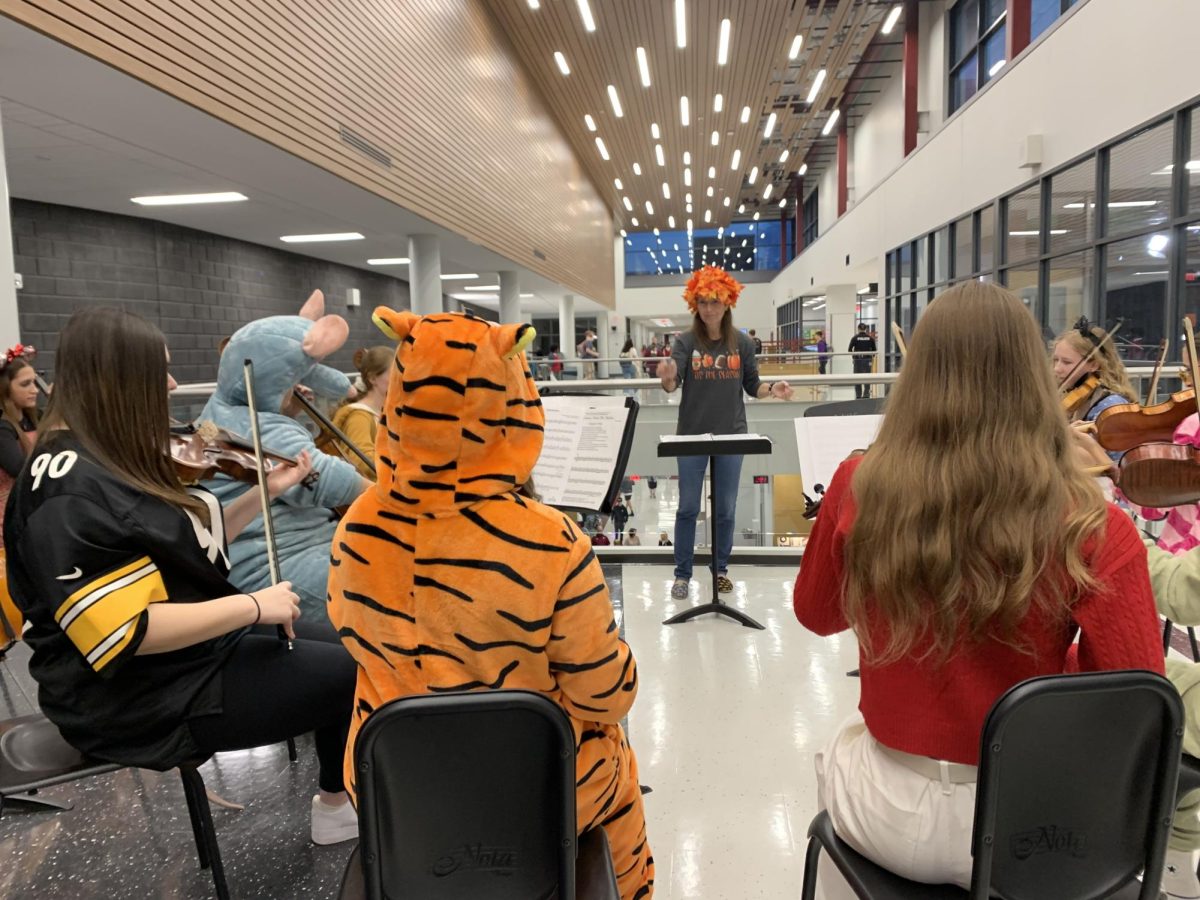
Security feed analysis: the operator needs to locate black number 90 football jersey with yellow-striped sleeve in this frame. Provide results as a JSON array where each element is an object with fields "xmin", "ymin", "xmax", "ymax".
[{"xmin": 5, "ymin": 432, "xmax": 240, "ymax": 769}]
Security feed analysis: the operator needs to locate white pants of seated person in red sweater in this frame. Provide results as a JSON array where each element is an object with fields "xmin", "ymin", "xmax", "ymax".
[{"xmin": 816, "ymin": 715, "xmax": 976, "ymax": 900}]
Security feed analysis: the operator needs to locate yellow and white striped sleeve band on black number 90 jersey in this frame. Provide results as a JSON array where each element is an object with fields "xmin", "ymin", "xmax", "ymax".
[{"xmin": 55, "ymin": 557, "xmax": 167, "ymax": 672}]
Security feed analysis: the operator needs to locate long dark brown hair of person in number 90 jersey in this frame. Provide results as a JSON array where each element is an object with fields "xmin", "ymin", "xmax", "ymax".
[{"xmin": 38, "ymin": 306, "xmax": 208, "ymax": 523}]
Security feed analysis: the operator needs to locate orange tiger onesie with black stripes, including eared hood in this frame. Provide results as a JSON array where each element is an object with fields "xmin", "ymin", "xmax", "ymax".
[{"xmin": 329, "ymin": 306, "xmax": 654, "ymax": 900}]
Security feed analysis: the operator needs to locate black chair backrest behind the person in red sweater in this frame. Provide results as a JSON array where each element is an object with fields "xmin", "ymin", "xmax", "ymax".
[{"xmin": 971, "ymin": 672, "xmax": 1183, "ymax": 900}]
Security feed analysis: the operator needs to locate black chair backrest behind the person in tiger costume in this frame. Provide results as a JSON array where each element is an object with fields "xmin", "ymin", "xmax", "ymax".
[{"xmin": 355, "ymin": 690, "xmax": 576, "ymax": 900}]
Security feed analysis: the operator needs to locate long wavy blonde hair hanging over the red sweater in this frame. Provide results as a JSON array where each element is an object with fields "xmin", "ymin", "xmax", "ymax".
[{"xmin": 845, "ymin": 281, "xmax": 1106, "ymax": 664}]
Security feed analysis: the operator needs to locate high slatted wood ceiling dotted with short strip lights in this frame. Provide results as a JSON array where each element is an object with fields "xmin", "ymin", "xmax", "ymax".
[{"xmin": 485, "ymin": 0, "xmax": 895, "ymax": 236}]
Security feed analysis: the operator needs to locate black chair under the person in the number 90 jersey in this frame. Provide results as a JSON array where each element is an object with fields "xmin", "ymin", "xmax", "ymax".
[{"xmin": 0, "ymin": 714, "xmax": 229, "ymax": 900}]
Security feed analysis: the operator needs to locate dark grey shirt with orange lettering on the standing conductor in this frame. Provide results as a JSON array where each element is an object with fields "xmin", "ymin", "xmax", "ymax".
[{"xmin": 671, "ymin": 331, "xmax": 762, "ymax": 434}]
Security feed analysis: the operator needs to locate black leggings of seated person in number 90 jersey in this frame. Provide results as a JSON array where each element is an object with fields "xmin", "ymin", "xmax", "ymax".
[{"xmin": 188, "ymin": 635, "xmax": 356, "ymax": 793}]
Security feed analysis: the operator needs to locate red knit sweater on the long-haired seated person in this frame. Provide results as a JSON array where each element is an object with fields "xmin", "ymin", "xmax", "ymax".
[{"xmin": 793, "ymin": 458, "xmax": 1163, "ymax": 766}]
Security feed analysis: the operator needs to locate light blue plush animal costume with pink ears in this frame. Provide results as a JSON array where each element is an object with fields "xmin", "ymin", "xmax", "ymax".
[{"xmin": 200, "ymin": 290, "xmax": 367, "ymax": 626}]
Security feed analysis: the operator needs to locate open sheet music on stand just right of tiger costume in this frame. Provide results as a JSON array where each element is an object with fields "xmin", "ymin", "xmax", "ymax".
[{"xmin": 533, "ymin": 396, "xmax": 629, "ymax": 510}]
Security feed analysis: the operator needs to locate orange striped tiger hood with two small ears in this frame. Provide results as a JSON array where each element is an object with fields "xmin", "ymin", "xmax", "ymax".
[{"xmin": 373, "ymin": 306, "xmax": 546, "ymax": 515}]
